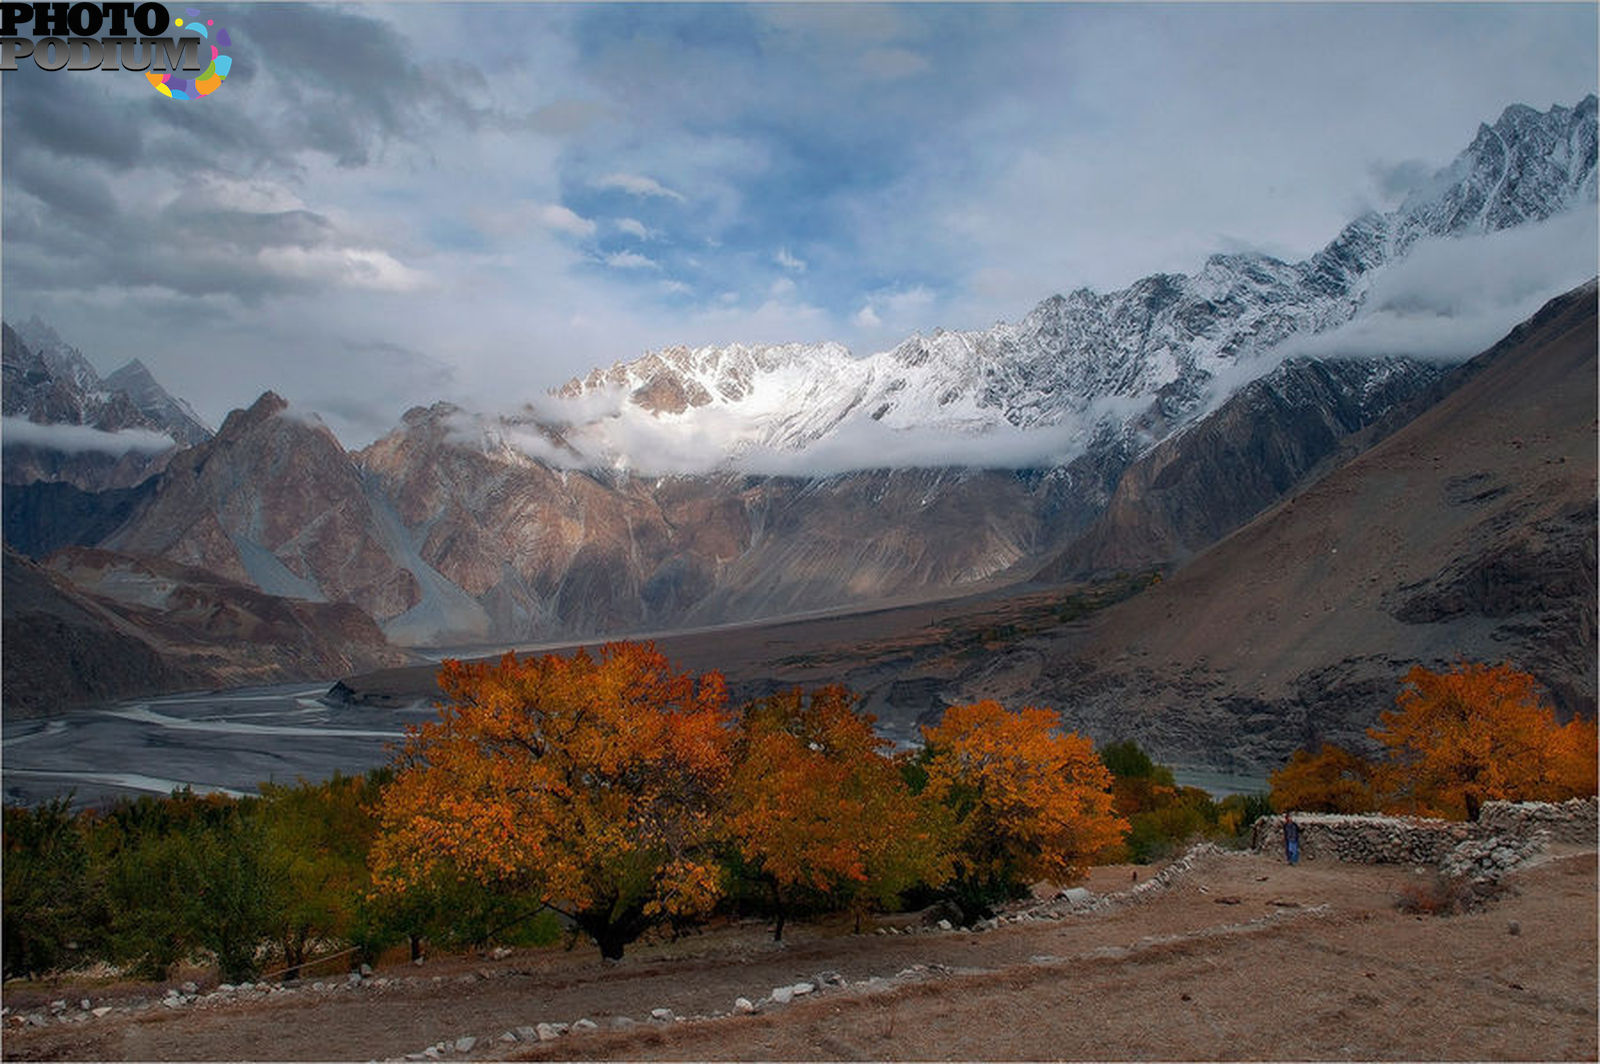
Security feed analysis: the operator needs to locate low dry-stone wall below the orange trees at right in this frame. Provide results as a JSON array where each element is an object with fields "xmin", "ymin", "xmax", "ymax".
[{"xmin": 1251, "ymin": 798, "xmax": 1600, "ymax": 867}]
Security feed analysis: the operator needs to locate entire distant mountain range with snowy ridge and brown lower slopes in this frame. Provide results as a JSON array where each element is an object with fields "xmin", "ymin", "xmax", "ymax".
[{"xmin": 5, "ymin": 96, "xmax": 1597, "ymax": 745}]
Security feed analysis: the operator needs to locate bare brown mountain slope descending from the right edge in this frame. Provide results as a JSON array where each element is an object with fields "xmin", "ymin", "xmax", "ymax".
[{"xmin": 963, "ymin": 283, "xmax": 1597, "ymax": 770}]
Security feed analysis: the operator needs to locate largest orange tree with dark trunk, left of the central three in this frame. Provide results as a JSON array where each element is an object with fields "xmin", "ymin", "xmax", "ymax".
[{"xmin": 371, "ymin": 643, "xmax": 733, "ymax": 958}]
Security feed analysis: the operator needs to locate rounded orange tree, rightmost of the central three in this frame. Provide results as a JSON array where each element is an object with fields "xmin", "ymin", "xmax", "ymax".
[{"xmin": 920, "ymin": 701, "xmax": 1128, "ymax": 920}]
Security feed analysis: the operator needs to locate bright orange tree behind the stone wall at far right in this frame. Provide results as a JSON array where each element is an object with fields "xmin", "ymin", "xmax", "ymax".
[{"xmin": 1370, "ymin": 662, "xmax": 1595, "ymax": 819}]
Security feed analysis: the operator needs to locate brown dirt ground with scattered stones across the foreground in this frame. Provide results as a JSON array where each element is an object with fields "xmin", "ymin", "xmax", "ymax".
[{"xmin": 3, "ymin": 851, "xmax": 1600, "ymax": 1061}]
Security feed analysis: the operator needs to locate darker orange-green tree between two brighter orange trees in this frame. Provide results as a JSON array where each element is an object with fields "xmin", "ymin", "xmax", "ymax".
[{"xmin": 728, "ymin": 686, "xmax": 944, "ymax": 941}]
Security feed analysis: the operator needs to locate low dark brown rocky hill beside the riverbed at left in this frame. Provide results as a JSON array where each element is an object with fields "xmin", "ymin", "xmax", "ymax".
[{"xmin": 0, "ymin": 547, "xmax": 410, "ymax": 718}]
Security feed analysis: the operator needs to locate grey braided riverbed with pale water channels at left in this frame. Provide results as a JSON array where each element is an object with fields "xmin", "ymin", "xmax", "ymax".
[{"xmin": 0, "ymin": 682, "xmax": 435, "ymax": 806}]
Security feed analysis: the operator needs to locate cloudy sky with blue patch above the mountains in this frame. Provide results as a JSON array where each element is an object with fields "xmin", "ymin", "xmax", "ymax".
[{"xmin": 0, "ymin": 3, "xmax": 1600, "ymax": 446}]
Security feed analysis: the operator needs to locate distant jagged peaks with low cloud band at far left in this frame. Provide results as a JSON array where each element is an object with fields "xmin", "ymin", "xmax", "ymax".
[{"xmin": 0, "ymin": 318, "xmax": 211, "ymax": 491}]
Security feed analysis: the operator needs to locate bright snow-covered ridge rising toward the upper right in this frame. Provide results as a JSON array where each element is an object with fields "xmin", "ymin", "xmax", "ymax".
[{"xmin": 524, "ymin": 96, "xmax": 1595, "ymax": 472}]
